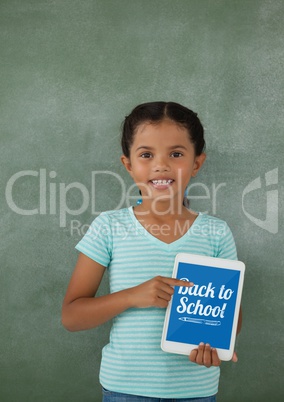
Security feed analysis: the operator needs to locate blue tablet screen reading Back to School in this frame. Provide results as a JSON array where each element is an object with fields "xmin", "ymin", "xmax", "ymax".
[{"xmin": 166, "ymin": 262, "xmax": 240, "ymax": 349}]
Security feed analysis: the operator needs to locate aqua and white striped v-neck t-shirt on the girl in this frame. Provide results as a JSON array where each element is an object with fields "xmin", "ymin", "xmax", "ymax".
[{"xmin": 76, "ymin": 207, "xmax": 237, "ymax": 398}]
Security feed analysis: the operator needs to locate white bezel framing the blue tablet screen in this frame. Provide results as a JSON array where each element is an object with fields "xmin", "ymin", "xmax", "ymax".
[{"xmin": 161, "ymin": 253, "xmax": 245, "ymax": 361}]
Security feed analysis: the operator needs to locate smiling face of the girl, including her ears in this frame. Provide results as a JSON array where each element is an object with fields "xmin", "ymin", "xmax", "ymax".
[{"xmin": 121, "ymin": 120, "xmax": 205, "ymax": 209}]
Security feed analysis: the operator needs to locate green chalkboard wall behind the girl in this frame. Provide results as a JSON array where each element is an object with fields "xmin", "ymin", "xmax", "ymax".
[{"xmin": 0, "ymin": 0, "xmax": 284, "ymax": 402}]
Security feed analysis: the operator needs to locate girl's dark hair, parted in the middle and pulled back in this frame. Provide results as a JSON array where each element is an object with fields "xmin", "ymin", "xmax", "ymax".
[{"xmin": 121, "ymin": 102, "xmax": 205, "ymax": 158}]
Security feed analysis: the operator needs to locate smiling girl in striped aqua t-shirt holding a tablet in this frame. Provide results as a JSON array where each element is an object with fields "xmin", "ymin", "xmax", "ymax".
[{"xmin": 62, "ymin": 102, "xmax": 241, "ymax": 402}]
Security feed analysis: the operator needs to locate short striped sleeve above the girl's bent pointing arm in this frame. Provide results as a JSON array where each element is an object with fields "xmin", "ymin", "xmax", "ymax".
[{"xmin": 75, "ymin": 213, "xmax": 112, "ymax": 267}]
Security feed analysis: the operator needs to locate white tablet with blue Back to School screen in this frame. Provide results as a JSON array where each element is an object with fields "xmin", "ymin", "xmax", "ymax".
[{"xmin": 161, "ymin": 253, "xmax": 245, "ymax": 360}]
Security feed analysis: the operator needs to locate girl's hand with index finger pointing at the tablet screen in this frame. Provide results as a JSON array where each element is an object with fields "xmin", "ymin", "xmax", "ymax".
[{"xmin": 127, "ymin": 276, "xmax": 193, "ymax": 308}]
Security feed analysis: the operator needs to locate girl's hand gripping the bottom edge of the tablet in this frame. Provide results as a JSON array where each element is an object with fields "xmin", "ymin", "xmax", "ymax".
[{"xmin": 189, "ymin": 342, "xmax": 238, "ymax": 367}]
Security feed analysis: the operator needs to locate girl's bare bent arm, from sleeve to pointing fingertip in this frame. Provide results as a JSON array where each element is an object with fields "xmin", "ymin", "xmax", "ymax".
[{"xmin": 62, "ymin": 254, "xmax": 193, "ymax": 331}]
